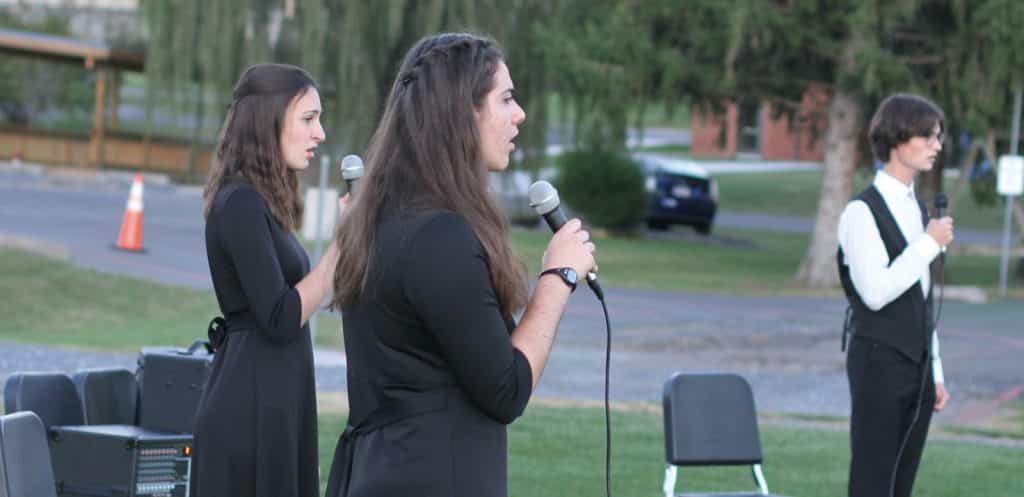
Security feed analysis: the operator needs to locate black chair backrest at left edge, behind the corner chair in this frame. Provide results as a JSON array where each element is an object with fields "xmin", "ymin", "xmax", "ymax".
[{"xmin": 3, "ymin": 373, "xmax": 85, "ymax": 429}]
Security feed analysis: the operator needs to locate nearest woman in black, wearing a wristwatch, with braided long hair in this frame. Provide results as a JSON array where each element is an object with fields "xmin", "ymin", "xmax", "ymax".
[{"xmin": 328, "ymin": 34, "xmax": 594, "ymax": 497}]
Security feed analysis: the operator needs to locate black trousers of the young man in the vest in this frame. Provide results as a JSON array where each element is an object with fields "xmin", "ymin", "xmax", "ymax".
[{"xmin": 846, "ymin": 337, "xmax": 935, "ymax": 497}]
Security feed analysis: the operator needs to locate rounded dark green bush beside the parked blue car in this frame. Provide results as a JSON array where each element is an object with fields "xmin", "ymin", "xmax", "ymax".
[{"xmin": 555, "ymin": 148, "xmax": 648, "ymax": 232}]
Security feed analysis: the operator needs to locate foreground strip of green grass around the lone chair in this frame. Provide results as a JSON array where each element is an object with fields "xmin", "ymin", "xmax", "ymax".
[{"xmin": 319, "ymin": 406, "xmax": 1024, "ymax": 497}]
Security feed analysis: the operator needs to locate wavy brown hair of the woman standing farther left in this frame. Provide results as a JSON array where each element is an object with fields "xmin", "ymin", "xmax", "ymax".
[{"xmin": 203, "ymin": 64, "xmax": 316, "ymax": 230}]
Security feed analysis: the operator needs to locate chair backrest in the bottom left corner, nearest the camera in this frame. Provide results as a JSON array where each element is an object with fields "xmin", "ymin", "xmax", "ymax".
[{"xmin": 0, "ymin": 412, "xmax": 57, "ymax": 497}]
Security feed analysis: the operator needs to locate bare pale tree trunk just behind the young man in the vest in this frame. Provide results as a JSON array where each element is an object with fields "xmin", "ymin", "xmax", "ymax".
[{"xmin": 797, "ymin": 91, "xmax": 862, "ymax": 288}]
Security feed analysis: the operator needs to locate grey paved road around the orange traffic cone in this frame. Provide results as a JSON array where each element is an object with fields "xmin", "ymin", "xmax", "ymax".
[{"xmin": 0, "ymin": 167, "xmax": 212, "ymax": 289}]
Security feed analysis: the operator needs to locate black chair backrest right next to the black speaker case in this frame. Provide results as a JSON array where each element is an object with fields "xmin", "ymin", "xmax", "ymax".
[{"xmin": 72, "ymin": 368, "xmax": 138, "ymax": 424}]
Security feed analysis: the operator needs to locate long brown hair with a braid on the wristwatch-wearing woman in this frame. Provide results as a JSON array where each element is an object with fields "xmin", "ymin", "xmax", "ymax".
[{"xmin": 331, "ymin": 33, "xmax": 527, "ymax": 314}]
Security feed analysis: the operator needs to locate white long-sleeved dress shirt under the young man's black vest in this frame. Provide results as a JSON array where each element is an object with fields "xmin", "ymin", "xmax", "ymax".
[{"xmin": 839, "ymin": 170, "xmax": 944, "ymax": 383}]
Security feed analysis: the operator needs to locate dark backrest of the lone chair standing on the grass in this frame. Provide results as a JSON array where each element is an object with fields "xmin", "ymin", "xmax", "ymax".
[{"xmin": 663, "ymin": 373, "xmax": 761, "ymax": 466}]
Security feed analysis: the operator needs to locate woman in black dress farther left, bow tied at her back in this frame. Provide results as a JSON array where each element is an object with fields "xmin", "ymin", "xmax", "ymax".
[{"xmin": 191, "ymin": 64, "xmax": 338, "ymax": 497}]
